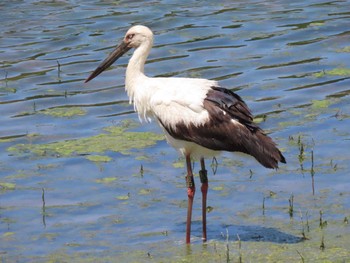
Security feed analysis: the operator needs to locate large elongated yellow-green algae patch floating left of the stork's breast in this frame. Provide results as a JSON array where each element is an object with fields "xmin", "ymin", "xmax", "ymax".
[{"xmin": 7, "ymin": 124, "xmax": 164, "ymax": 162}]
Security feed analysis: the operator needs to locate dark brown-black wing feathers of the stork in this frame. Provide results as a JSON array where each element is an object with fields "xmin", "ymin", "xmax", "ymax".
[{"xmin": 159, "ymin": 87, "xmax": 285, "ymax": 168}]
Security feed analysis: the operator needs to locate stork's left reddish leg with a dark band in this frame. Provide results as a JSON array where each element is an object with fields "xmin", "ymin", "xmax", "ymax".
[{"xmin": 186, "ymin": 155, "xmax": 196, "ymax": 244}]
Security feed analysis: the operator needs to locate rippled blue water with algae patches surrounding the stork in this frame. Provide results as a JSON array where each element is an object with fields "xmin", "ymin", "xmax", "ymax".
[{"xmin": 0, "ymin": 0, "xmax": 350, "ymax": 262}]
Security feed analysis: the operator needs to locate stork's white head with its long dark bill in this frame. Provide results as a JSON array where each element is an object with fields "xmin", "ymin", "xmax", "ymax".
[{"xmin": 85, "ymin": 25, "xmax": 153, "ymax": 82}]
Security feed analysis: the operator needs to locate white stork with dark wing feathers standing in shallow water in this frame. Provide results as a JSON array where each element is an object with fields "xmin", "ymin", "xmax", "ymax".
[{"xmin": 85, "ymin": 25, "xmax": 286, "ymax": 244}]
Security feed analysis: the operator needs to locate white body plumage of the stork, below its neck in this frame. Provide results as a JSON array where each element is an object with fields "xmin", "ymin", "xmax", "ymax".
[{"xmin": 133, "ymin": 77, "xmax": 216, "ymax": 159}]
